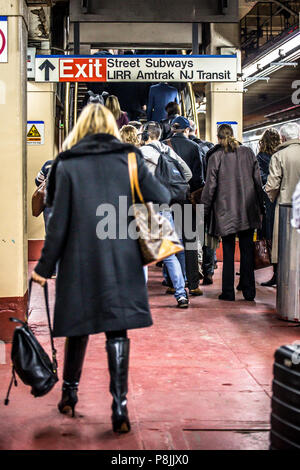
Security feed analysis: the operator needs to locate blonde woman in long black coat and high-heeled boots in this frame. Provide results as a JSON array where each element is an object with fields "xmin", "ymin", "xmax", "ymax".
[{"xmin": 32, "ymin": 104, "xmax": 170, "ymax": 432}]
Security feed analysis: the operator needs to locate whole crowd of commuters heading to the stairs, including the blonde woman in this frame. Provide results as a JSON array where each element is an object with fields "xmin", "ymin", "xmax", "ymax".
[{"xmin": 32, "ymin": 84, "xmax": 300, "ymax": 432}]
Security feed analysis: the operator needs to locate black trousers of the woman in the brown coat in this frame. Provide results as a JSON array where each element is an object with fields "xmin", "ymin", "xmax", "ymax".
[{"xmin": 222, "ymin": 230, "xmax": 255, "ymax": 298}]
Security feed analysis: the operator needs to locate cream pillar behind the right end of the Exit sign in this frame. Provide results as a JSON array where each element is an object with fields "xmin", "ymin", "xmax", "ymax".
[{"xmin": 205, "ymin": 23, "xmax": 243, "ymax": 143}]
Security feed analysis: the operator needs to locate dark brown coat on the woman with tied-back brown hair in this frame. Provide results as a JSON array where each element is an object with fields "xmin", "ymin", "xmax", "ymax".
[{"xmin": 201, "ymin": 145, "xmax": 264, "ymax": 237}]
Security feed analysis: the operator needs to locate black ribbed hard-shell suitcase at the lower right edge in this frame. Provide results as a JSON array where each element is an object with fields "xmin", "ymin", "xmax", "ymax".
[{"xmin": 270, "ymin": 344, "xmax": 300, "ymax": 450}]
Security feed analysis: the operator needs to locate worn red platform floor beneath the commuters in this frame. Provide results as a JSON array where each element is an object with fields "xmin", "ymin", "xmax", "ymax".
[{"xmin": 0, "ymin": 263, "xmax": 300, "ymax": 450}]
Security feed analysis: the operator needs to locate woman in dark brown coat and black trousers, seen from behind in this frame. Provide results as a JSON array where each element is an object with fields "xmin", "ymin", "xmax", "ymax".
[{"xmin": 201, "ymin": 124, "xmax": 263, "ymax": 300}]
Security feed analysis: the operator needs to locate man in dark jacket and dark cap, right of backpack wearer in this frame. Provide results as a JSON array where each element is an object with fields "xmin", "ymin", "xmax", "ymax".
[{"xmin": 165, "ymin": 116, "xmax": 204, "ymax": 295}]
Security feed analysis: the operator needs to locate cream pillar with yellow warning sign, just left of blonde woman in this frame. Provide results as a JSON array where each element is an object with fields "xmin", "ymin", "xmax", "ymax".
[{"xmin": 27, "ymin": 81, "xmax": 58, "ymax": 260}]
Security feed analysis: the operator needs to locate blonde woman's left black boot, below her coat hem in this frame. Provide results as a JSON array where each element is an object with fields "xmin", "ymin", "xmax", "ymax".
[{"xmin": 58, "ymin": 336, "xmax": 89, "ymax": 417}]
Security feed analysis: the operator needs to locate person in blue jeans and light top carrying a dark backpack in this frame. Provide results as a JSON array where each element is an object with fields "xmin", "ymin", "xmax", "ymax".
[{"xmin": 140, "ymin": 121, "xmax": 192, "ymax": 308}]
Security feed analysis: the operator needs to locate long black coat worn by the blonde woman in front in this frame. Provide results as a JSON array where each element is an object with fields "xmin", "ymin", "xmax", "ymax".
[{"xmin": 35, "ymin": 134, "xmax": 170, "ymax": 336}]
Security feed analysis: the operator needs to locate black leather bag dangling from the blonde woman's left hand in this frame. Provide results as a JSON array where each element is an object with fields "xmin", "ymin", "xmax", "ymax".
[{"xmin": 4, "ymin": 279, "xmax": 58, "ymax": 405}]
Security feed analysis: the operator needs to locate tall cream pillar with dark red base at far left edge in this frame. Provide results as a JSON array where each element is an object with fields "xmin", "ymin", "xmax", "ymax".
[{"xmin": 0, "ymin": 0, "xmax": 27, "ymax": 341}]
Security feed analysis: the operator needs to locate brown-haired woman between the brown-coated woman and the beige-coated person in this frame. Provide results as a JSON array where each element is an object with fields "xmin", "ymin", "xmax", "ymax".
[{"xmin": 257, "ymin": 128, "xmax": 281, "ymax": 287}]
